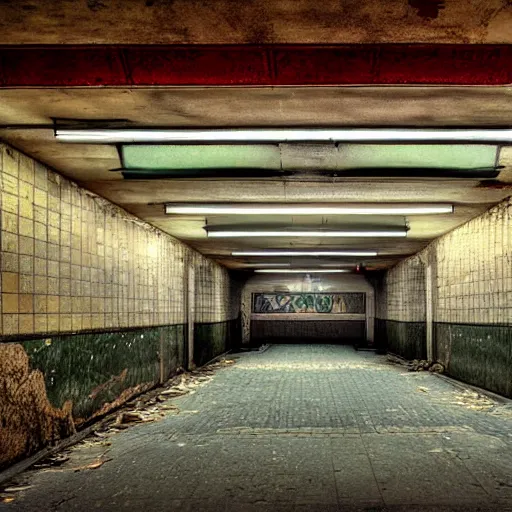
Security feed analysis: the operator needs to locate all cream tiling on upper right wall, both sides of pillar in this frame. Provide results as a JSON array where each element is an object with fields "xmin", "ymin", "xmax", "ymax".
[{"xmin": 377, "ymin": 199, "xmax": 512, "ymax": 324}]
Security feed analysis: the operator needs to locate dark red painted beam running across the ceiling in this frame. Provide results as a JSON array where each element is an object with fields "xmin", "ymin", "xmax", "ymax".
[{"xmin": 0, "ymin": 44, "xmax": 512, "ymax": 87}]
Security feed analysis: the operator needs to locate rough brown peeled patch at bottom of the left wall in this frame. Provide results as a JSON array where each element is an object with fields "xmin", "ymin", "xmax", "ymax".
[{"xmin": 0, "ymin": 344, "xmax": 75, "ymax": 468}]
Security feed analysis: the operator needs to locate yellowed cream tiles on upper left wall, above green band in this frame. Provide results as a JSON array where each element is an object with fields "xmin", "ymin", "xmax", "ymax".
[{"xmin": 0, "ymin": 145, "xmax": 232, "ymax": 336}]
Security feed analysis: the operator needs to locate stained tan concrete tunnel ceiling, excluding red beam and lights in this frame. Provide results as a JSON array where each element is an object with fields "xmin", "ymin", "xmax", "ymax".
[{"xmin": 0, "ymin": 0, "xmax": 512, "ymax": 269}]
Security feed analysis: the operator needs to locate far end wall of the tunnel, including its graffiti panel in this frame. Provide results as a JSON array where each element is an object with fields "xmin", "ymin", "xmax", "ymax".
[{"xmin": 241, "ymin": 274, "xmax": 374, "ymax": 344}]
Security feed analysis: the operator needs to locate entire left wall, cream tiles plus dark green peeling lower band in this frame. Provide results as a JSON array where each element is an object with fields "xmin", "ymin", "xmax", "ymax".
[{"xmin": 0, "ymin": 144, "xmax": 240, "ymax": 469}]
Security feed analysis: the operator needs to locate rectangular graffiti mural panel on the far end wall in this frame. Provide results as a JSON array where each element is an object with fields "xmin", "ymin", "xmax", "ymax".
[{"xmin": 253, "ymin": 293, "xmax": 365, "ymax": 314}]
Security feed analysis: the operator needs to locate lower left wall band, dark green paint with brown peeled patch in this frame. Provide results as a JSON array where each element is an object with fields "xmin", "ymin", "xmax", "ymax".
[{"xmin": 0, "ymin": 325, "xmax": 186, "ymax": 467}]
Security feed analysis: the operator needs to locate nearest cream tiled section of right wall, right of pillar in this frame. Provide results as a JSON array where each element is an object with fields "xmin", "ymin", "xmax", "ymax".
[{"xmin": 430, "ymin": 199, "xmax": 512, "ymax": 324}]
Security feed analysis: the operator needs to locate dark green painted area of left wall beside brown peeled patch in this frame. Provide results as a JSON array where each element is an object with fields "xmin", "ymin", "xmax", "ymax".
[{"xmin": 21, "ymin": 325, "xmax": 186, "ymax": 419}]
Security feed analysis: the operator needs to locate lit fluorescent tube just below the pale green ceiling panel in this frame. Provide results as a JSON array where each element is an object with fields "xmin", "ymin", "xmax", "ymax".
[{"xmin": 165, "ymin": 203, "xmax": 453, "ymax": 215}]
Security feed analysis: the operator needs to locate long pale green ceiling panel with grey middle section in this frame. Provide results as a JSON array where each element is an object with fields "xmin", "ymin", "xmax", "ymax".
[{"xmin": 121, "ymin": 144, "xmax": 498, "ymax": 179}]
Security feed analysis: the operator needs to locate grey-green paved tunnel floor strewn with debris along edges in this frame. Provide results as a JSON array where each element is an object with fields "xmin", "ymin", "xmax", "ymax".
[{"xmin": 0, "ymin": 345, "xmax": 512, "ymax": 512}]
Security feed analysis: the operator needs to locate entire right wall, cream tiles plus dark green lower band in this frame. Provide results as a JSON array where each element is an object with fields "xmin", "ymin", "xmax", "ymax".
[{"xmin": 376, "ymin": 198, "xmax": 512, "ymax": 397}]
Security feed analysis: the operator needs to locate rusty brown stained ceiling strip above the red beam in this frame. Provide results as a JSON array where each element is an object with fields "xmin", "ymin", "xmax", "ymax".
[{"xmin": 0, "ymin": 0, "xmax": 512, "ymax": 45}]
